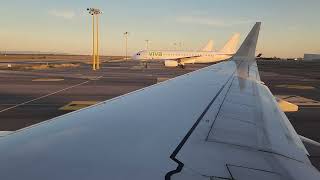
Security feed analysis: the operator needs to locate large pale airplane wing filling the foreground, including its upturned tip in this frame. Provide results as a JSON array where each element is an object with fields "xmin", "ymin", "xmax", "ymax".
[{"xmin": 0, "ymin": 23, "xmax": 320, "ymax": 180}]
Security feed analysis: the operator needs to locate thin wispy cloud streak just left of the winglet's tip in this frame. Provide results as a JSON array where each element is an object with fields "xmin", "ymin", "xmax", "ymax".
[{"xmin": 176, "ymin": 16, "xmax": 253, "ymax": 27}]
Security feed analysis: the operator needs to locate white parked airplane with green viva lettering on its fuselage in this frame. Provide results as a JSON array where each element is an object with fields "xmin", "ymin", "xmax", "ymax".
[{"xmin": 132, "ymin": 33, "xmax": 240, "ymax": 67}]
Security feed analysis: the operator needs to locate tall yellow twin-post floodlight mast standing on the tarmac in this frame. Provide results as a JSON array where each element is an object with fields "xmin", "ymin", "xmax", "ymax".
[{"xmin": 87, "ymin": 8, "xmax": 102, "ymax": 71}]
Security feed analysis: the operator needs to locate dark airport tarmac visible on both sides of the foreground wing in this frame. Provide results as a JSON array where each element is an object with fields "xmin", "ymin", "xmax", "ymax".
[{"xmin": 0, "ymin": 61, "xmax": 320, "ymax": 169}]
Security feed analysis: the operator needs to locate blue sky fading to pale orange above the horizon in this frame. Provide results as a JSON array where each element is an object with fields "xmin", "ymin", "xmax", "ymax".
[{"xmin": 0, "ymin": 0, "xmax": 320, "ymax": 57}]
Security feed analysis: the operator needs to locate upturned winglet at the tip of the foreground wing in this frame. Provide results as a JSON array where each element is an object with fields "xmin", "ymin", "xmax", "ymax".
[{"xmin": 235, "ymin": 22, "xmax": 261, "ymax": 58}]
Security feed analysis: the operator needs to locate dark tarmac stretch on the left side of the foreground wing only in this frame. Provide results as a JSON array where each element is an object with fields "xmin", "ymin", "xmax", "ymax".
[{"xmin": 0, "ymin": 62, "xmax": 200, "ymax": 131}]
